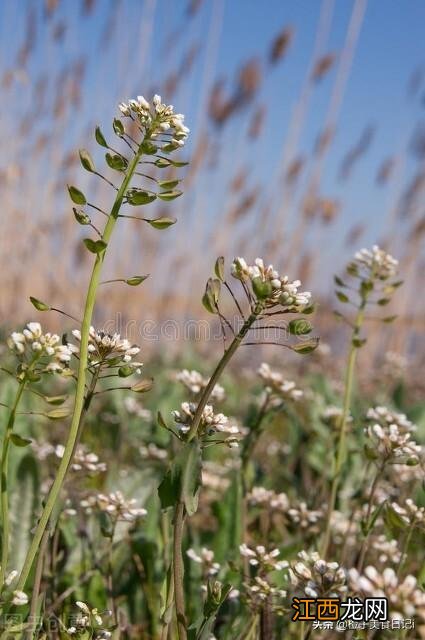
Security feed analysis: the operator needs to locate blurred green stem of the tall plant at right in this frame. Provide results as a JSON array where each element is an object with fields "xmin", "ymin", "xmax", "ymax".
[{"xmin": 321, "ymin": 298, "xmax": 366, "ymax": 559}]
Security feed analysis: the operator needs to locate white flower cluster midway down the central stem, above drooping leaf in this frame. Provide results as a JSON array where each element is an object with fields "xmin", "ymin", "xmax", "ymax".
[{"xmin": 173, "ymin": 402, "xmax": 241, "ymax": 447}]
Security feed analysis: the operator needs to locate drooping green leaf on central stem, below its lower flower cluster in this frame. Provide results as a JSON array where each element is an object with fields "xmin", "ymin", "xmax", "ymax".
[{"xmin": 158, "ymin": 438, "xmax": 202, "ymax": 516}]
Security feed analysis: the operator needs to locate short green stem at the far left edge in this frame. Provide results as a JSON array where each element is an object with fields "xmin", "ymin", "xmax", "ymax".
[{"xmin": 0, "ymin": 376, "xmax": 27, "ymax": 586}]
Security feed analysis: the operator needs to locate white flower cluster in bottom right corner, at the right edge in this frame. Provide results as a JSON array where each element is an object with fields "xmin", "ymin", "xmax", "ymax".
[{"xmin": 348, "ymin": 566, "xmax": 425, "ymax": 620}]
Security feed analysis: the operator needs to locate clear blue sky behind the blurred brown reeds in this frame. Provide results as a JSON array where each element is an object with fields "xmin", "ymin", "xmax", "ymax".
[{"xmin": 0, "ymin": 0, "xmax": 425, "ymax": 290}]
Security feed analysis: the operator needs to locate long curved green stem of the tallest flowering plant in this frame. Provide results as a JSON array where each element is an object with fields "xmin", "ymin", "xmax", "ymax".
[{"xmin": 17, "ymin": 136, "xmax": 148, "ymax": 590}]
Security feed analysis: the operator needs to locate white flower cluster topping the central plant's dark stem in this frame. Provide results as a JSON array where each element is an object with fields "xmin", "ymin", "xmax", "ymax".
[{"xmin": 231, "ymin": 258, "xmax": 311, "ymax": 311}]
